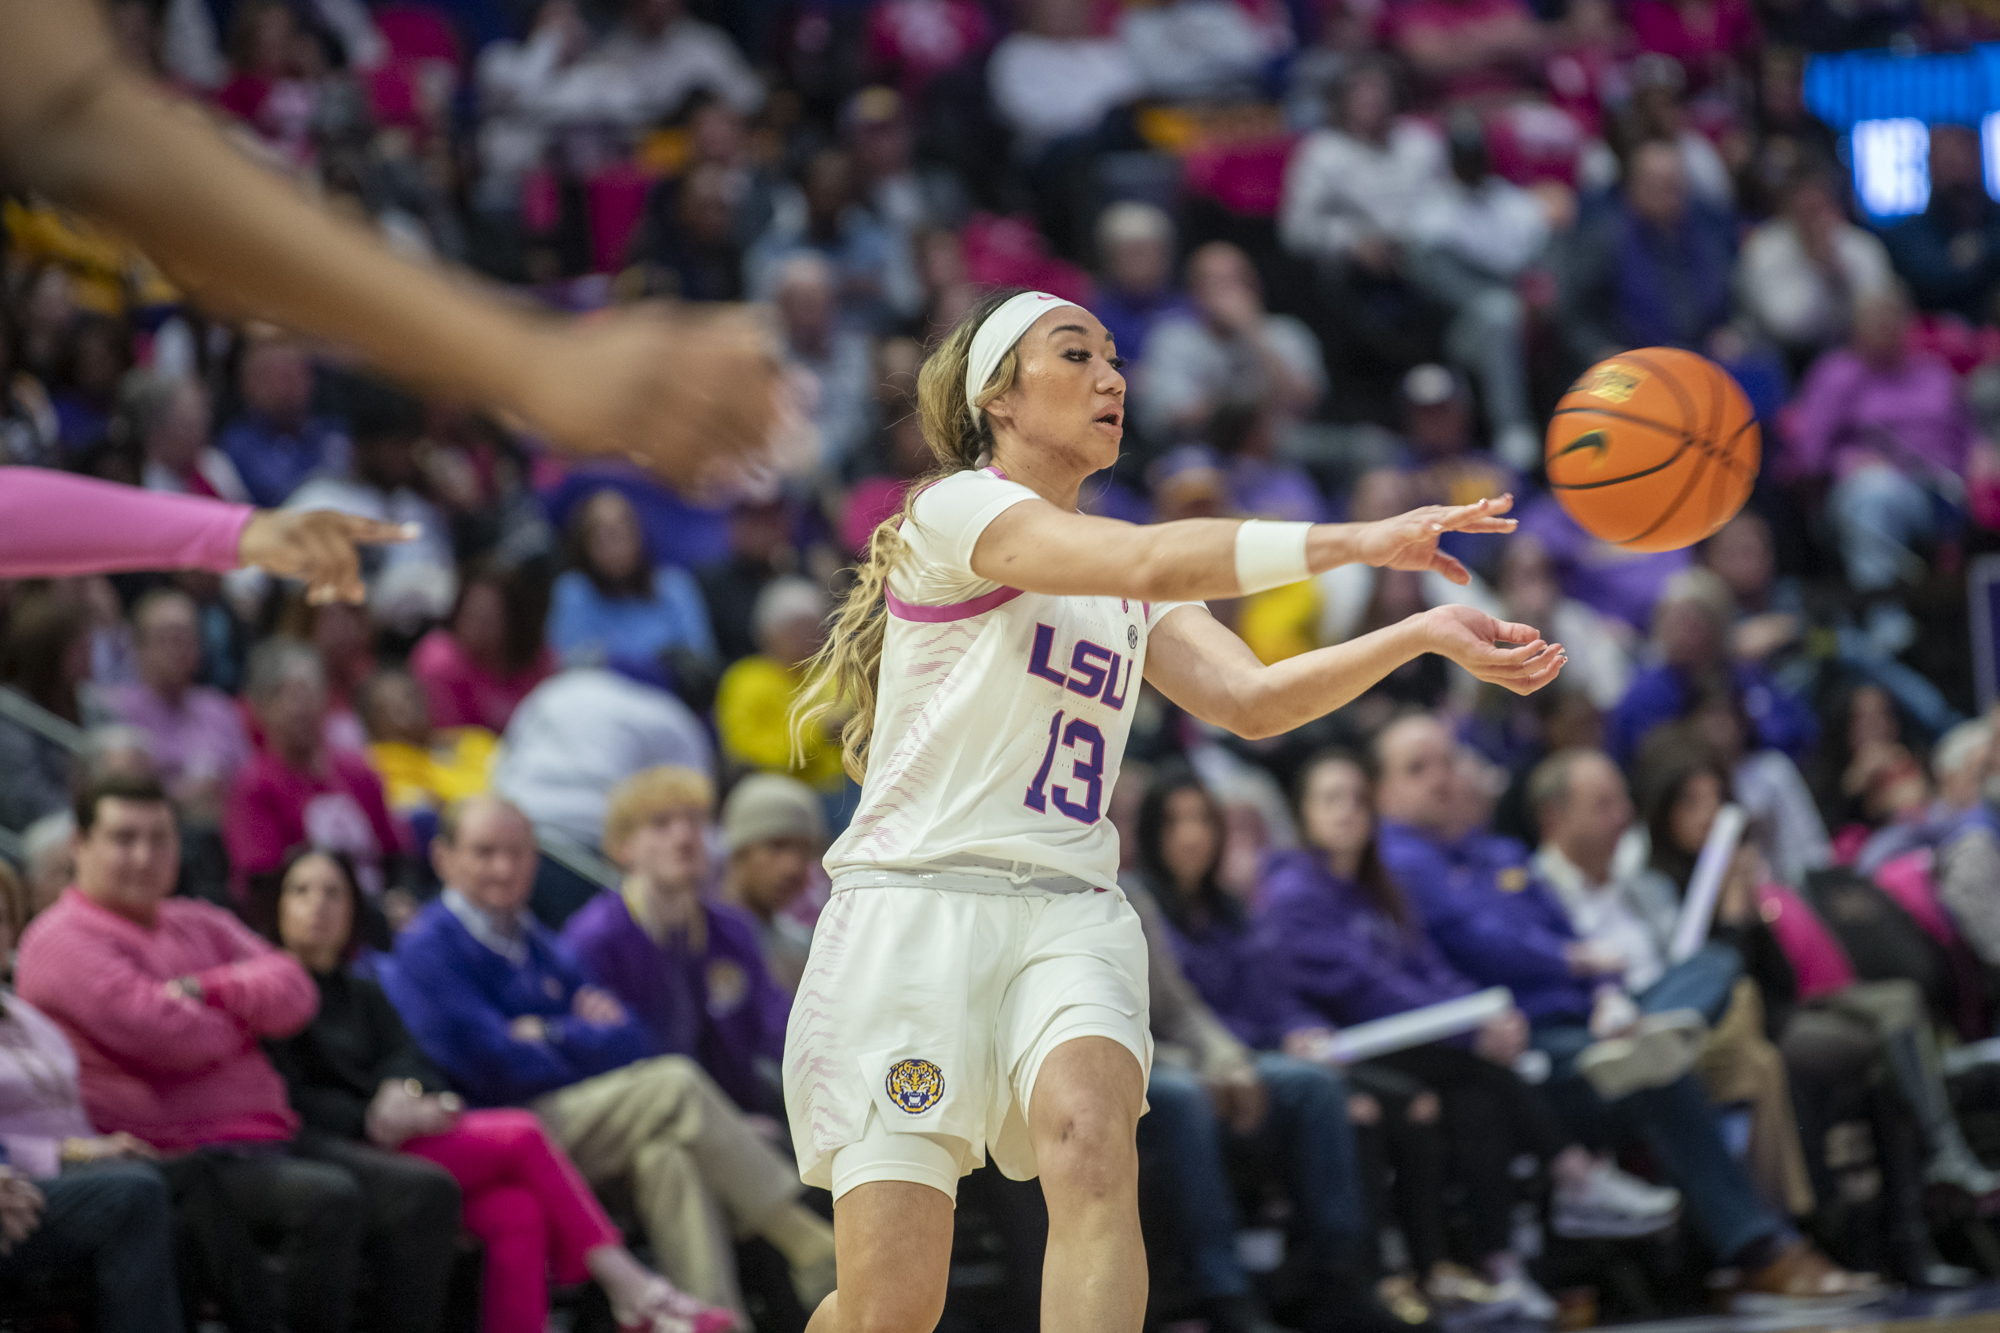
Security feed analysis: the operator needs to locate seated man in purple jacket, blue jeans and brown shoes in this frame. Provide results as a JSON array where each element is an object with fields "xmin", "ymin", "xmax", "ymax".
[{"xmin": 1374, "ymin": 715, "xmax": 1874, "ymax": 1301}]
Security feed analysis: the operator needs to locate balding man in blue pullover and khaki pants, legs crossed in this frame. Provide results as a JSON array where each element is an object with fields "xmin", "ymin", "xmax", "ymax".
[{"xmin": 382, "ymin": 797, "xmax": 834, "ymax": 1327}]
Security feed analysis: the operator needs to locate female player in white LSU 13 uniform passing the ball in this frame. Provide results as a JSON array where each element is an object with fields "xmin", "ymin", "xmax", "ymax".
[{"xmin": 784, "ymin": 282, "xmax": 1564, "ymax": 1333}]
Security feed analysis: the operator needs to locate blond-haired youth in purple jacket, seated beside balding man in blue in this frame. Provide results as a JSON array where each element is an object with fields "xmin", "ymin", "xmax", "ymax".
[{"xmin": 562, "ymin": 765, "xmax": 792, "ymax": 1113}]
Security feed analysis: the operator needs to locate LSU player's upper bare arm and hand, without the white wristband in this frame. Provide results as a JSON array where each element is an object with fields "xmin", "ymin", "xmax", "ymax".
[{"xmin": 972, "ymin": 496, "xmax": 1514, "ymax": 602}]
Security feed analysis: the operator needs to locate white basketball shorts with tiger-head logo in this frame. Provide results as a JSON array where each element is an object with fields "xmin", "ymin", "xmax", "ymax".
[{"xmin": 784, "ymin": 873, "xmax": 1152, "ymax": 1199}]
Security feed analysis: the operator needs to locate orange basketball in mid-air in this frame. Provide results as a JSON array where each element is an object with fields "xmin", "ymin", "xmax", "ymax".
[{"xmin": 1548, "ymin": 346, "xmax": 1760, "ymax": 550}]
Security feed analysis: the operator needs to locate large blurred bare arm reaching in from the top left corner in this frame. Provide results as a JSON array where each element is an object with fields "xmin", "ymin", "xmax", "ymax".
[{"xmin": 0, "ymin": 0, "xmax": 778, "ymax": 484}]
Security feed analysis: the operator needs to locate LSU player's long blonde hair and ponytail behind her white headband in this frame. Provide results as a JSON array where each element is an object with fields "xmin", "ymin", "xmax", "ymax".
[{"xmin": 792, "ymin": 286, "xmax": 1022, "ymax": 783}]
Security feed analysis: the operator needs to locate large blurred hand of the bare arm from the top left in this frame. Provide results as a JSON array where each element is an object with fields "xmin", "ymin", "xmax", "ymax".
[{"xmin": 518, "ymin": 304, "xmax": 786, "ymax": 492}]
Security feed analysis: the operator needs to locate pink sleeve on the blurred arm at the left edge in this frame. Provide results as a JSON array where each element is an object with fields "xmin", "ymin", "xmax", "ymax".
[{"xmin": 0, "ymin": 468, "xmax": 256, "ymax": 578}]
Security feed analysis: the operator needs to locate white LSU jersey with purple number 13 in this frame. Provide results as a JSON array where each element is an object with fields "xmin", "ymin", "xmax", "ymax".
[{"xmin": 826, "ymin": 468, "xmax": 1200, "ymax": 889}]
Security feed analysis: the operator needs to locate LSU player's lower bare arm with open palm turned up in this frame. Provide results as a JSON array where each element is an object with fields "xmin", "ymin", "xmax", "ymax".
[{"xmin": 1146, "ymin": 604, "xmax": 1568, "ymax": 739}]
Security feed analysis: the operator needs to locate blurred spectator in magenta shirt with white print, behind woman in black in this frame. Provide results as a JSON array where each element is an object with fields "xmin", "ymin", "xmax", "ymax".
[{"xmin": 224, "ymin": 638, "xmax": 404, "ymax": 909}]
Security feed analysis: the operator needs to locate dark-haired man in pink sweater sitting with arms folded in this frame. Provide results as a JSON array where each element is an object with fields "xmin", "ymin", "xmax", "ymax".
[{"xmin": 16, "ymin": 777, "xmax": 376, "ymax": 1333}]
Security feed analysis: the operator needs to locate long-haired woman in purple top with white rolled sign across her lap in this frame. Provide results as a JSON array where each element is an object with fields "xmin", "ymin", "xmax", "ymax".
[{"xmin": 1260, "ymin": 751, "xmax": 1680, "ymax": 1319}]
